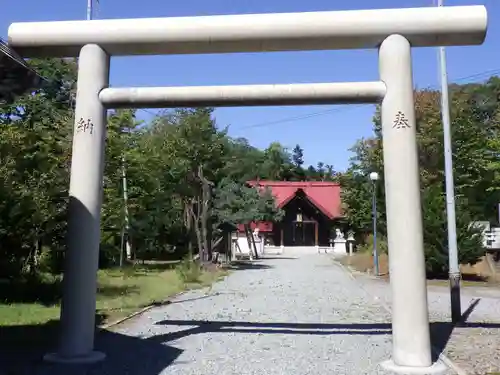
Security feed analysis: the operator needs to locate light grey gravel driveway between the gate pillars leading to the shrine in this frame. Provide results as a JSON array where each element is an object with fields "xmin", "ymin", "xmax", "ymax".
[{"xmin": 106, "ymin": 254, "xmax": 450, "ymax": 375}]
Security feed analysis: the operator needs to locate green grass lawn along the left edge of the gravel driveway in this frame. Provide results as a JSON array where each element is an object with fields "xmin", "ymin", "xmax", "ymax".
[{"xmin": 0, "ymin": 262, "xmax": 224, "ymax": 326}]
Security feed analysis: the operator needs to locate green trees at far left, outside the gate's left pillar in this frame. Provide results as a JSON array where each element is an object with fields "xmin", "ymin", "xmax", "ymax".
[{"xmin": 0, "ymin": 59, "xmax": 76, "ymax": 276}]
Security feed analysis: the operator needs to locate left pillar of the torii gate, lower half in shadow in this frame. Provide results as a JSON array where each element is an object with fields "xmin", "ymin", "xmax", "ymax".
[{"xmin": 45, "ymin": 44, "xmax": 109, "ymax": 363}]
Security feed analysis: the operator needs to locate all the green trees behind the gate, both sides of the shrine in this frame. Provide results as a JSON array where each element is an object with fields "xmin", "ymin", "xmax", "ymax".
[{"xmin": 0, "ymin": 59, "xmax": 500, "ymax": 280}]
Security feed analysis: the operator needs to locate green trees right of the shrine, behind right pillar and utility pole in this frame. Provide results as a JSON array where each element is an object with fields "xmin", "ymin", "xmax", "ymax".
[{"xmin": 339, "ymin": 77, "xmax": 500, "ymax": 274}]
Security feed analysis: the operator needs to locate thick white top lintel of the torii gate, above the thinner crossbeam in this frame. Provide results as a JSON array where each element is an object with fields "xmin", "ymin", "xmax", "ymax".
[{"xmin": 8, "ymin": 5, "xmax": 488, "ymax": 57}]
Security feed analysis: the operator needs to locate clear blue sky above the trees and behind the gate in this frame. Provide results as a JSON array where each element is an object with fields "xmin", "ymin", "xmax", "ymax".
[{"xmin": 0, "ymin": 0, "xmax": 500, "ymax": 170}]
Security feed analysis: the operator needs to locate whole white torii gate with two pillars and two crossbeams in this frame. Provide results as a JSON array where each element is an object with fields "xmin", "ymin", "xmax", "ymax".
[{"xmin": 8, "ymin": 6, "xmax": 487, "ymax": 374}]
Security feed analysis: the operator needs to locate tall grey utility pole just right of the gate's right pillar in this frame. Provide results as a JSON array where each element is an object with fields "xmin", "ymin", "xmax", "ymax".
[{"xmin": 437, "ymin": 0, "xmax": 462, "ymax": 323}]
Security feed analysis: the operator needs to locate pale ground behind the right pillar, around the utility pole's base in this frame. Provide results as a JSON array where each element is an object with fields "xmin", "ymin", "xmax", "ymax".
[{"xmin": 348, "ymin": 266, "xmax": 500, "ymax": 375}]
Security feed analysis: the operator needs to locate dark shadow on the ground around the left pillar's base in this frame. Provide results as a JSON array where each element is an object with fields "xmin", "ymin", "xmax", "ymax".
[{"xmin": 0, "ymin": 321, "xmax": 182, "ymax": 375}]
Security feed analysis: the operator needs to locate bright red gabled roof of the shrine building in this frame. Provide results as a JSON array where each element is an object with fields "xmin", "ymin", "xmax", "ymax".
[{"xmin": 248, "ymin": 181, "xmax": 342, "ymax": 219}]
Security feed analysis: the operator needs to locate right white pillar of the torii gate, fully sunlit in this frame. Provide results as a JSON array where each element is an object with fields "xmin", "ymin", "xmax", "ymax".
[{"xmin": 379, "ymin": 35, "xmax": 441, "ymax": 373}]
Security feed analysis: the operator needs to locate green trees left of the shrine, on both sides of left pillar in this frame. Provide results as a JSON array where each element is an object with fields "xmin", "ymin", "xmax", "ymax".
[{"xmin": 0, "ymin": 59, "xmax": 334, "ymax": 279}]
